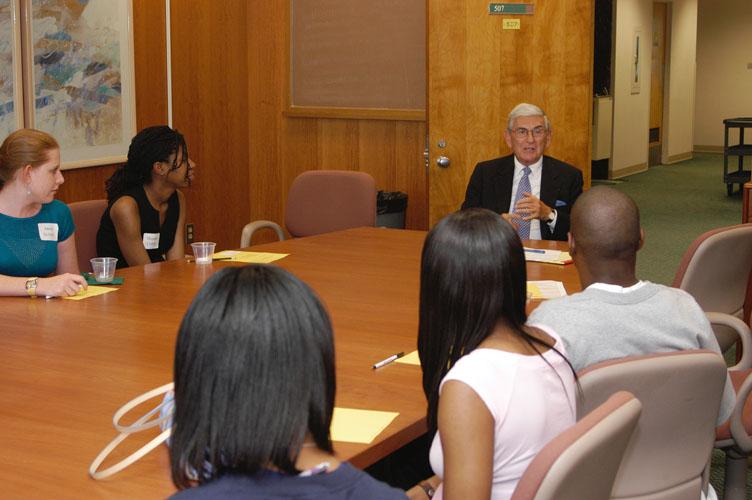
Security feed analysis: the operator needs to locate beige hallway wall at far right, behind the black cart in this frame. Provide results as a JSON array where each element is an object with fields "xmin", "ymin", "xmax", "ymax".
[{"xmin": 694, "ymin": 0, "xmax": 752, "ymax": 150}]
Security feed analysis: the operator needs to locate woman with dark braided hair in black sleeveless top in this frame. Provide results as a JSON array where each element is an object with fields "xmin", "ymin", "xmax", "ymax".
[{"xmin": 97, "ymin": 125, "xmax": 195, "ymax": 267}]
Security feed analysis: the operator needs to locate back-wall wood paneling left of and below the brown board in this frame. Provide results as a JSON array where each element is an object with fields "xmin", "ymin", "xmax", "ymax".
[{"xmin": 248, "ymin": 0, "xmax": 428, "ymax": 241}]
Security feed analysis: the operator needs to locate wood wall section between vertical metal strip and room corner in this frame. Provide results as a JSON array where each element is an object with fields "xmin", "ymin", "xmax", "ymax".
[{"xmin": 171, "ymin": 0, "xmax": 255, "ymax": 248}]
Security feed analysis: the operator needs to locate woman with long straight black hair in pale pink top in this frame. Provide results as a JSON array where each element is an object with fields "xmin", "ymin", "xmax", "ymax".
[{"xmin": 418, "ymin": 209, "xmax": 576, "ymax": 500}]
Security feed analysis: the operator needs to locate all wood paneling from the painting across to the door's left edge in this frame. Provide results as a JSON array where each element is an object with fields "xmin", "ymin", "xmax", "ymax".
[{"xmin": 59, "ymin": 0, "xmax": 428, "ymax": 248}]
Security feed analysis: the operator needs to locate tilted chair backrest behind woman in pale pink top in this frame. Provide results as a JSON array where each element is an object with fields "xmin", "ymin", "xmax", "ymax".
[{"xmin": 512, "ymin": 391, "xmax": 642, "ymax": 500}]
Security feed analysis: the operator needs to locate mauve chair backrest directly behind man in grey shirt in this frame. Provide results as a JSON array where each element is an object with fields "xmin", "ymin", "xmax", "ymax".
[{"xmin": 577, "ymin": 350, "xmax": 726, "ymax": 500}]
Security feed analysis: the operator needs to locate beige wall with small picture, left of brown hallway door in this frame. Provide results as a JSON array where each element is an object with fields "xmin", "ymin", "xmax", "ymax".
[{"xmin": 609, "ymin": 0, "xmax": 653, "ymax": 178}]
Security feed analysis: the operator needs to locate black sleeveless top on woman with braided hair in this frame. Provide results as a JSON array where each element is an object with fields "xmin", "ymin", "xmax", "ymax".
[{"xmin": 97, "ymin": 186, "xmax": 180, "ymax": 268}]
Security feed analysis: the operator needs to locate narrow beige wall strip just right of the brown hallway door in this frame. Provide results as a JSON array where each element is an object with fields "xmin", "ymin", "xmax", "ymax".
[{"xmin": 661, "ymin": 0, "xmax": 700, "ymax": 163}]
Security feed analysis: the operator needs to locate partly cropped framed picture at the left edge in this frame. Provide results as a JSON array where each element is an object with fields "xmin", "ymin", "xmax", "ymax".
[{"xmin": 0, "ymin": 0, "xmax": 24, "ymax": 141}]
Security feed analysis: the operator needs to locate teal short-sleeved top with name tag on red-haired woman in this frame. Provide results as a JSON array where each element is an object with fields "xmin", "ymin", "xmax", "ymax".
[{"xmin": 0, "ymin": 200, "xmax": 76, "ymax": 277}]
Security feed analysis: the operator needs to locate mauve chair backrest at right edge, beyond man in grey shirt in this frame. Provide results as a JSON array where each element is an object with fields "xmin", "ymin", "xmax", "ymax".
[{"xmin": 673, "ymin": 224, "xmax": 752, "ymax": 350}]
